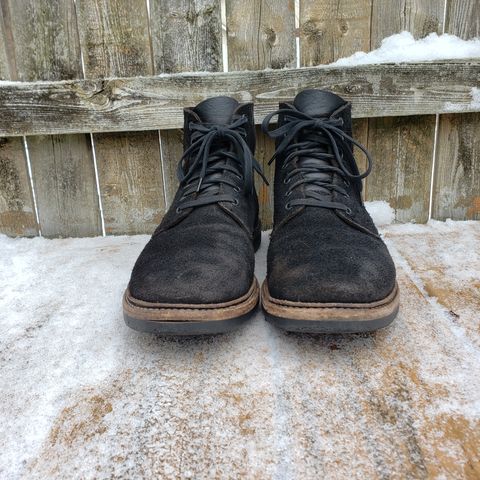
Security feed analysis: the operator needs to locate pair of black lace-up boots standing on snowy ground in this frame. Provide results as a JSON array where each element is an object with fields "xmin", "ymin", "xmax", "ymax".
[{"xmin": 123, "ymin": 90, "xmax": 399, "ymax": 335}]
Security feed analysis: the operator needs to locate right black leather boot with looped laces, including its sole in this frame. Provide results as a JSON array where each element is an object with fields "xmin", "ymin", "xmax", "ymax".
[{"xmin": 262, "ymin": 90, "xmax": 399, "ymax": 333}]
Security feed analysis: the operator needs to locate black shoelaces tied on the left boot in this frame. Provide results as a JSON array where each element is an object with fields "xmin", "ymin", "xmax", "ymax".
[{"xmin": 177, "ymin": 116, "xmax": 266, "ymax": 211}]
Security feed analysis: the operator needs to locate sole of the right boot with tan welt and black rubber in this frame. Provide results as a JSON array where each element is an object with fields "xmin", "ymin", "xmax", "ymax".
[{"xmin": 262, "ymin": 281, "xmax": 400, "ymax": 333}]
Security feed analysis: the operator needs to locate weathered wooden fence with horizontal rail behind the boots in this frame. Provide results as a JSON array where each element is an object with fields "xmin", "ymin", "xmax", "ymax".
[{"xmin": 0, "ymin": 0, "xmax": 480, "ymax": 237}]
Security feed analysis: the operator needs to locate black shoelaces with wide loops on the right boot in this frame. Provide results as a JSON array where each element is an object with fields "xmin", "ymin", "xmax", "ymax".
[{"xmin": 262, "ymin": 108, "xmax": 372, "ymax": 213}]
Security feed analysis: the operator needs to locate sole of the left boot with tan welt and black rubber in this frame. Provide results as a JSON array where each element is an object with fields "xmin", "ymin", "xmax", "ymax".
[{"xmin": 123, "ymin": 278, "xmax": 260, "ymax": 335}]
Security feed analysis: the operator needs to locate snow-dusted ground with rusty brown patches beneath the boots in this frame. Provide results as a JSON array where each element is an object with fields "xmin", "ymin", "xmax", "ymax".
[{"xmin": 0, "ymin": 222, "xmax": 480, "ymax": 480}]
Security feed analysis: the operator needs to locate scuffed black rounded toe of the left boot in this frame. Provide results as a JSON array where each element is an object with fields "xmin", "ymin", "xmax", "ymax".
[{"xmin": 129, "ymin": 226, "xmax": 254, "ymax": 304}]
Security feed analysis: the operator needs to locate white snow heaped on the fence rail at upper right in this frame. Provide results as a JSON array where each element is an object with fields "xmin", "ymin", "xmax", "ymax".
[{"xmin": 330, "ymin": 31, "xmax": 480, "ymax": 67}]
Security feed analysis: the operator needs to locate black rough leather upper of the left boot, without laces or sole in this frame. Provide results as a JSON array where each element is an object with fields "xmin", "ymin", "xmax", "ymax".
[{"xmin": 129, "ymin": 97, "xmax": 259, "ymax": 304}]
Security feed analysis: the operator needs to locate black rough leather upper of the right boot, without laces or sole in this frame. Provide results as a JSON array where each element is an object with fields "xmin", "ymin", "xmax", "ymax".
[{"xmin": 267, "ymin": 90, "xmax": 396, "ymax": 303}]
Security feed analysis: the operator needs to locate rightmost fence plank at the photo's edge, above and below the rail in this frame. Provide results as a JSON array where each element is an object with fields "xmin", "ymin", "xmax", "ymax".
[{"xmin": 432, "ymin": 0, "xmax": 480, "ymax": 220}]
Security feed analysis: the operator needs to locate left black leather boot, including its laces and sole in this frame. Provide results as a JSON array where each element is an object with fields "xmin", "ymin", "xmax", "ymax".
[{"xmin": 123, "ymin": 97, "xmax": 261, "ymax": 335}]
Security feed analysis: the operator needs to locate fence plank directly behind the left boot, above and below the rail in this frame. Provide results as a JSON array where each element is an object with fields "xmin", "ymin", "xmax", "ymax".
[{"xmin": 150, "ymin": 0, "xmax": 223, "ymax": 205}]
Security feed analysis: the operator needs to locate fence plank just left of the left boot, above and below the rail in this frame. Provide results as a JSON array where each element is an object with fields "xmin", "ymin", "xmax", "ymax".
[{"xmin": 77, "ymin": 0, "xmax": 165, "ymax": 234}]
